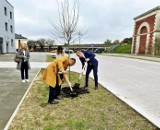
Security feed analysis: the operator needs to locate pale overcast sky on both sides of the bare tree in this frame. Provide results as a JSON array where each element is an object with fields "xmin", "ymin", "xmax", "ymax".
[{"xmin": 8, "ymin": 0, "xmax": 160, "ymax": 43}]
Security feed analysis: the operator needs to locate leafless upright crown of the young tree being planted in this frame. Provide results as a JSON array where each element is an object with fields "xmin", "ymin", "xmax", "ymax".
[{"xmin": 51, "ymin": 0, "xmax": 79, "ymax": 53}]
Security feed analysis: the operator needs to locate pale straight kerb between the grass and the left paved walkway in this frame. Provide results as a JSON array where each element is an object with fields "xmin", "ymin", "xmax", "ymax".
[{"xmin": 4, "ymin": 69, "xmax": 41, "ymax": 130}]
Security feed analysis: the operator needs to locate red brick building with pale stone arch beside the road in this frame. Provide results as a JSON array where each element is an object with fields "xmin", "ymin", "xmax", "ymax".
[{"xmin": 132, "ymin": 6, "xmax": 160, "ymax": 55}]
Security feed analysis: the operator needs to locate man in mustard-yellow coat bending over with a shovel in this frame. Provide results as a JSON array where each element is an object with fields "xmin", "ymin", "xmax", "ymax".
[{"xmin": 43, "ymin": 56, "xmax": 76, "ymax": 104}]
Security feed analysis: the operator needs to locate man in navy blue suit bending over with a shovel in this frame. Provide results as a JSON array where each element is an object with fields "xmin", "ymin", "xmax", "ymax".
[{"xmin": 76, "ymin": 50, "xmax": 98, "ymax": 89}]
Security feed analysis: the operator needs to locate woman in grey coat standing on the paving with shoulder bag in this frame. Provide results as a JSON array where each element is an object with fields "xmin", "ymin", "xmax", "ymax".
[{"xmin": 17, "ymin": 43, "xmax": 30, "ymax": 83}]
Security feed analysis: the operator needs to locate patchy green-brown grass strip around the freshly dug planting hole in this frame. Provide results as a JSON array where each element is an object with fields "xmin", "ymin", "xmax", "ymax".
[{"xmin": 9, "ymin": 55, "xmax": 158, "ymax": 130}]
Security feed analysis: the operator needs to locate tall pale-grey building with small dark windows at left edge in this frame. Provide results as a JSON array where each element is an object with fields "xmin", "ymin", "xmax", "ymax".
[{"xmin": 0, "ymin": 0, "xmax": 15, "ymax": 54}]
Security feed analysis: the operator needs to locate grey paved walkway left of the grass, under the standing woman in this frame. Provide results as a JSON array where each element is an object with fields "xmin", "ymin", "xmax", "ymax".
[{"xmin": 0, "ymin": 68, "xmax": 39, "ymax": 129}]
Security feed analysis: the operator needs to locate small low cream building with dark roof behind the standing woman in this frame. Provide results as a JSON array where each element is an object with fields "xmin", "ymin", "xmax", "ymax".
[{"xmin": 15, "ymin": 33, "xmax": 28, "ymax": 50}]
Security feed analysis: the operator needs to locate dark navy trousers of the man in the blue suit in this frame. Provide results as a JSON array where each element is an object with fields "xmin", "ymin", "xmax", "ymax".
[{"xmin": 85, "ymin": 62, "xmax": 98, "ymax": 87}]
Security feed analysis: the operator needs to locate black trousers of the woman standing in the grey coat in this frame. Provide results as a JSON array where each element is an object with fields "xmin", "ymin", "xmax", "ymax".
[{"xmin": 21, "ymin": 62, "xmax": 28, "ymax": 80}]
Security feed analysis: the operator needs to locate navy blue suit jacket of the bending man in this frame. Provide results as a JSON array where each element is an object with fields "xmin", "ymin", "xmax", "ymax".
[{"xmin": 79, "ymin": 51, "xmax": 98, "ymax": 67}]
